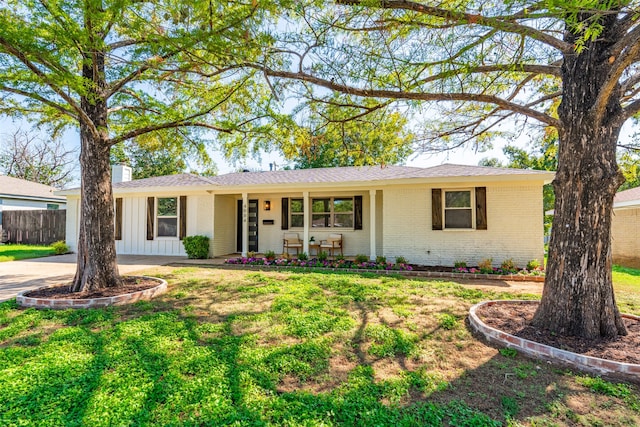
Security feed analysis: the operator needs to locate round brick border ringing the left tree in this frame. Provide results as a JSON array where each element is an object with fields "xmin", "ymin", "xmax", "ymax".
[{"xmin": 16, "ymin": 276, "xmax": 167, "ymax": 309}]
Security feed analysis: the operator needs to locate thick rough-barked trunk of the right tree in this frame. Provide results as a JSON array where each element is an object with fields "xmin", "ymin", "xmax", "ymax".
[{"xmin": 533, "ymin": 14, "xmax": 626, "ymax": 339}]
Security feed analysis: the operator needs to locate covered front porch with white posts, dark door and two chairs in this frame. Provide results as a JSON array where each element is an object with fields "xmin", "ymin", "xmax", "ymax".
[{"xmin": 212, "ymin": 188, "xmax": 383, "ymax": 259}]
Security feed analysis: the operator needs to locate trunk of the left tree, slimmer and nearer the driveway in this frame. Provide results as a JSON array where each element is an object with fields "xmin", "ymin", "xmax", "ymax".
[{"xmin": 73, "ymin": 43, "xmax": 121, "ymax": 292}]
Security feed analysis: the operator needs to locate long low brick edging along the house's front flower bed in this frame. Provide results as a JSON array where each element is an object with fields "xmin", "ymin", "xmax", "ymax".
[{"xmin": 168, "ymin": 262, "xmax": 544, "ymax": 283}]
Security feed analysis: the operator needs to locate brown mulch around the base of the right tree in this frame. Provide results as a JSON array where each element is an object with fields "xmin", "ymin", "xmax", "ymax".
[{"xmin": 476, "ymin": 303, "xmax": 640, "ymax": 364}]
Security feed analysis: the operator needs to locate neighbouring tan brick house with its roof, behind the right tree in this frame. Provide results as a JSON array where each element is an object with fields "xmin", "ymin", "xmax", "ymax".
[{"xmin": 611, "ymin": 187, "xmax": 640, "ymax": 268}]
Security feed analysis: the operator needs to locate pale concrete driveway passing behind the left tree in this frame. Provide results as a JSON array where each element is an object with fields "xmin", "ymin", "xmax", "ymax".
[{"xmin": 0, "ymin": 254, "xmax": 187, "ymax": 302}]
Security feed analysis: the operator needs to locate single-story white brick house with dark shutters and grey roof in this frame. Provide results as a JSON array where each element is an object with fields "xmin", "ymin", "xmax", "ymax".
[{"xmin": 59, "ymin": 164, "xmax": 554, "ymax": 266}]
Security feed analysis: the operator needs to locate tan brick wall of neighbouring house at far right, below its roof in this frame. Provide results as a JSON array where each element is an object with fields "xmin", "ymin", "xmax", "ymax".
[{"xmin": 611, "ymin": 208, "xmax": 640, "ymax": 268}]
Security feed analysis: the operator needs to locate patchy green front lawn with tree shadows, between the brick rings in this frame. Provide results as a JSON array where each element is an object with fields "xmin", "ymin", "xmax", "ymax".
[{"xmin": 0, "ymin": 267, "xmax": 640, "ymax": 426}]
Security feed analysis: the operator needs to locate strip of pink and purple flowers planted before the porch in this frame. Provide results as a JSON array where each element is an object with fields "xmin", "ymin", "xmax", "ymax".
[{"xmin": 224, "ymin": 257, "xmax": 413, "ymax": 271}]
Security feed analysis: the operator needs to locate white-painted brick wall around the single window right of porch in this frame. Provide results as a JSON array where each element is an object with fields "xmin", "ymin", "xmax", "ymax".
[{"xmin": 383, "ymin": 184, "xmax": 544, "ymax": 267}]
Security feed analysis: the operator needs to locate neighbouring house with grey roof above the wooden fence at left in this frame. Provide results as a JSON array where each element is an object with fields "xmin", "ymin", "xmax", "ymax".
[{"xmin": 0, "ymin": 175, "xmax": 67, "ymax": 212}]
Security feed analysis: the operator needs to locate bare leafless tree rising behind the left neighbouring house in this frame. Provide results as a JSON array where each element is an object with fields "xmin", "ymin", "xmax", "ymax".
[{"xmin": 0, "ymin": 129, "xmax": 77, "ymax": 188}]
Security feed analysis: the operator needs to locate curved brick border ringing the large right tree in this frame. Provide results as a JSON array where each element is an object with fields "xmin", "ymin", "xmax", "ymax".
[{"xmin": 469, "ymin": 300, "xmax": 640, "ymax": 383}]
